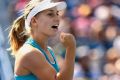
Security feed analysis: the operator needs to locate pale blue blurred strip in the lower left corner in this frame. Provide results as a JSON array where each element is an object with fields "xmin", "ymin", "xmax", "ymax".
[{"xmin": 0, "ymin": 26, "xmax": 14, "ymax": 80}]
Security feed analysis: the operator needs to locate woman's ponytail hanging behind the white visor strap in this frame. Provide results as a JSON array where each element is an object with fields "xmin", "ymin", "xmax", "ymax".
[{"xmin": 9, "ymin": 15, "xmax": 28, "ymax": 55}]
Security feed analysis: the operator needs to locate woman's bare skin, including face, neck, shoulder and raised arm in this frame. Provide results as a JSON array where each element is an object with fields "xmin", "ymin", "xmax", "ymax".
[{"xmin": 15, "ymin": 8, "xmax": 76, "ymax": 80}]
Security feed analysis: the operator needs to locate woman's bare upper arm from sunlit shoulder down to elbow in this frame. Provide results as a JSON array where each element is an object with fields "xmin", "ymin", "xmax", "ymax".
[{"xmin": 15, "ymin": 45, "xmax": 56, "ymax": 80}]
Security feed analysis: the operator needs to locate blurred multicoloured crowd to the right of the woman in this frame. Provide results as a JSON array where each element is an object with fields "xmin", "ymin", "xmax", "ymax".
[{"xmin": 63, "ymin": 0, "xmax": 120, "ymax": 80}]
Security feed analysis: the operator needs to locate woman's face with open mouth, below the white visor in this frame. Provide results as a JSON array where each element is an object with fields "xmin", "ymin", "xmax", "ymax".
[{"xmin": 32, "ymin": 8, "xmax": 59, "ymax": 36}]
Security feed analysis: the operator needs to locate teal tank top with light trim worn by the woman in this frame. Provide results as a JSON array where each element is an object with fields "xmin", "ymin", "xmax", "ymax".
[{"xmin": 14, "ymin": 38, "xmax": 59, "ymax": 80}]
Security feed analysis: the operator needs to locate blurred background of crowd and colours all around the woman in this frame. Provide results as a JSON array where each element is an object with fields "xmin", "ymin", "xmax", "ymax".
[{"xmin": 0, "ymin": 0, "xmax": 120, "ymax": 80}]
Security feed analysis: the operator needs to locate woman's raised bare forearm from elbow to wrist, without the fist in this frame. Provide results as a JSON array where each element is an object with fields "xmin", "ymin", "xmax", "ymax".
[{"xmin": 57, "ymin": 47, "xmax": 75, "ymax": 80}]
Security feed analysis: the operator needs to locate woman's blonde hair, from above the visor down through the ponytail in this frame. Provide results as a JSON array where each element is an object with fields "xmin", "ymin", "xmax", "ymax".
[{"xmin": 9, "ymin": 0, "xmax": 42, "ymax": 55}]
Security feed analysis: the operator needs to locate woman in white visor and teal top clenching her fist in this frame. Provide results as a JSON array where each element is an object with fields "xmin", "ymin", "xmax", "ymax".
[{"xmin": 9, "ymin": 0, "xmax": 76, "ymax": 80}]
